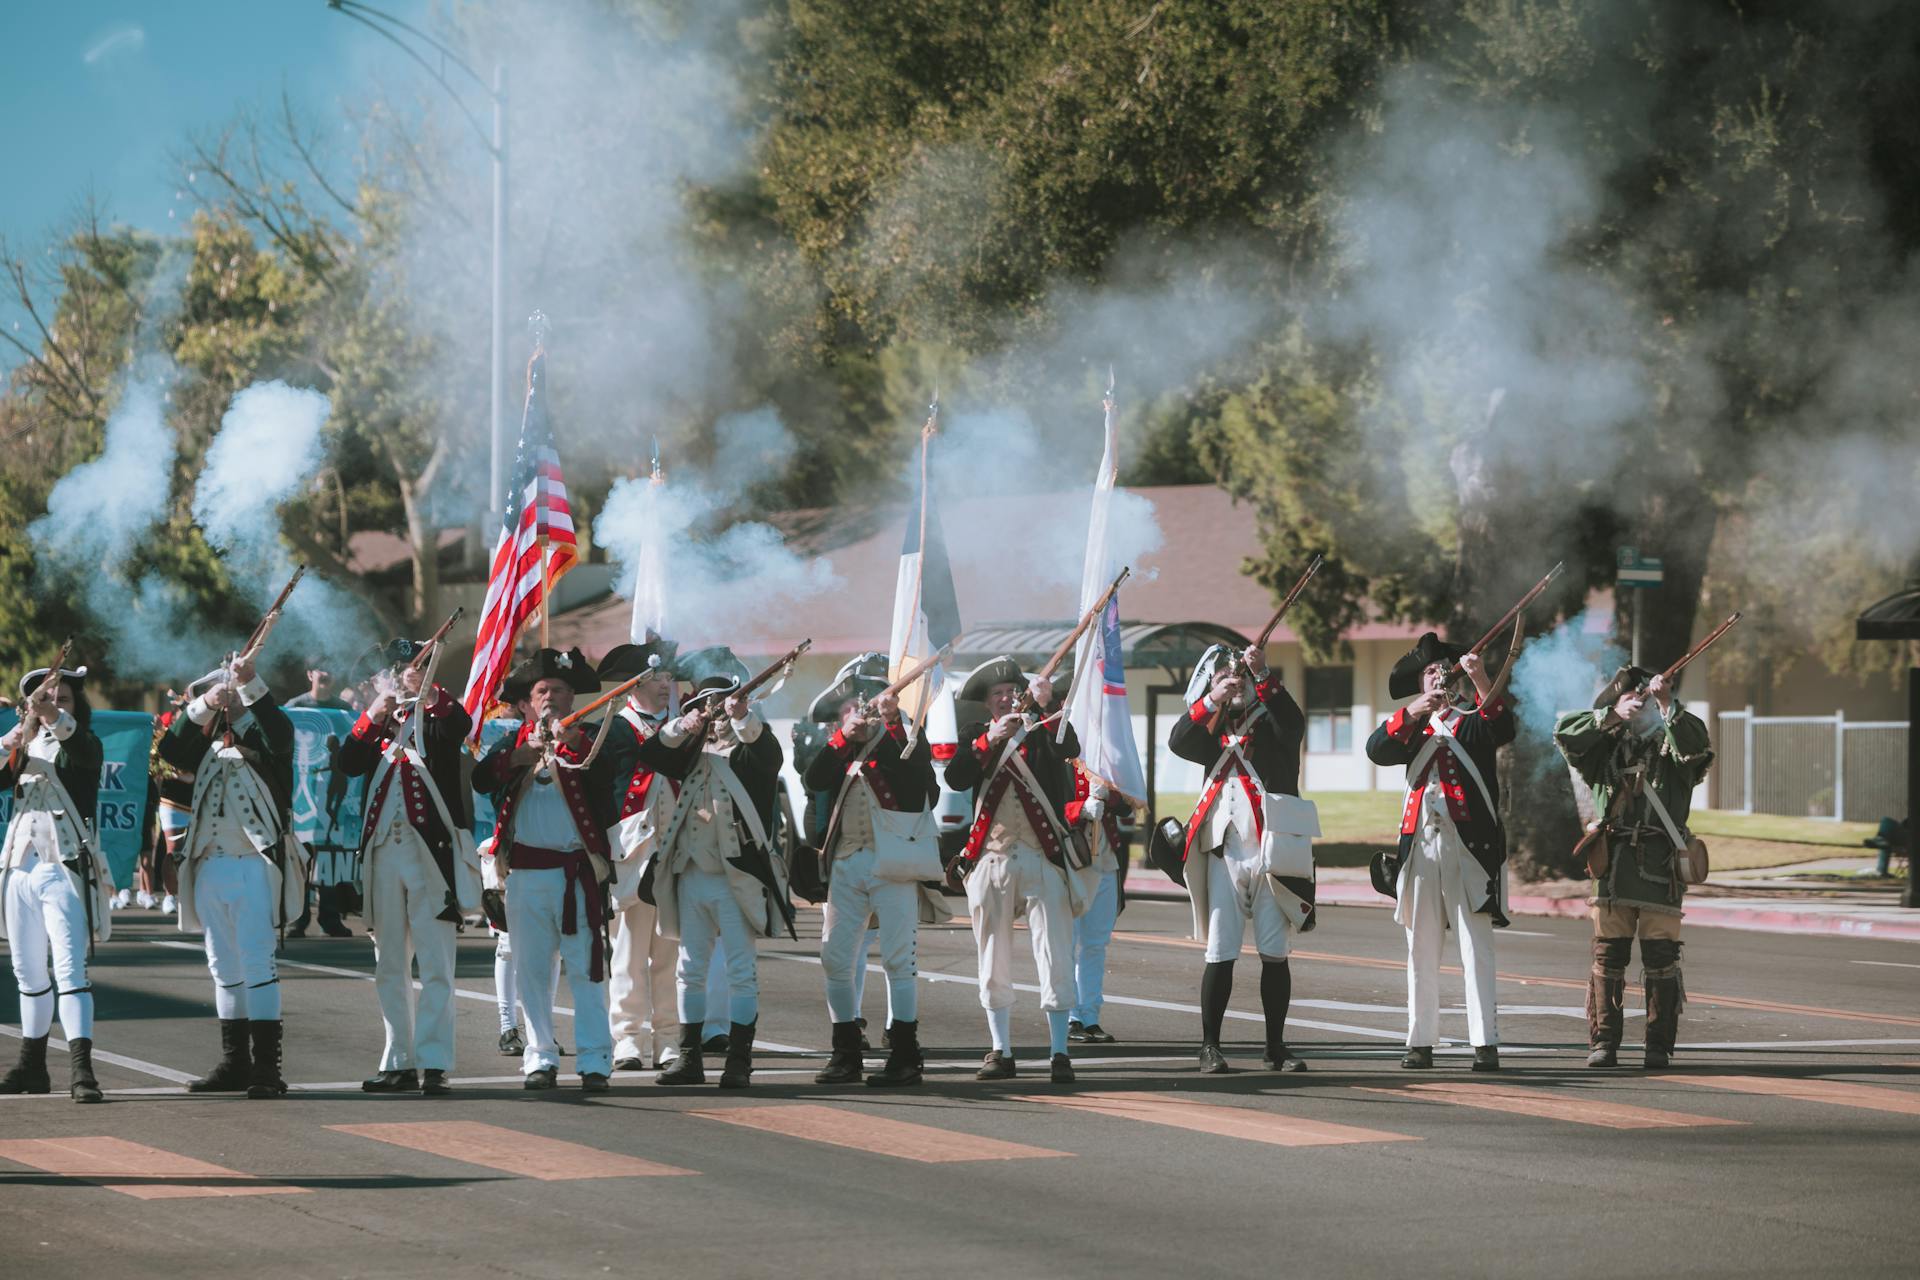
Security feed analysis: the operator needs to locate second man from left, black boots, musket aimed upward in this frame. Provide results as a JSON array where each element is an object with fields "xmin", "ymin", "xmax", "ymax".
[{"xmin": 159, "ymin": 654, "xmax": 307, "ymax": 1098}]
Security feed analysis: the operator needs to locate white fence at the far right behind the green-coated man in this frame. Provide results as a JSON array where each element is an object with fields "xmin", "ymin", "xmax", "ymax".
[{"xmin": 1709, "ymin": 706, "xmax": 1907, "ymax": 821}]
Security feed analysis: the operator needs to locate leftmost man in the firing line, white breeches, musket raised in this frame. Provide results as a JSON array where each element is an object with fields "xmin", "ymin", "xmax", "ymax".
[{"xmin": 0, "ymin": 666, "xmax": 113, "ymax": 1102}]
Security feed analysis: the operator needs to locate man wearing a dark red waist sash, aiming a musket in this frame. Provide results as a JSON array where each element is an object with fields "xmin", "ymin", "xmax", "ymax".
[{"xmin": 472, "ymin": 649, "xmax": 614, "ymax": 1094}]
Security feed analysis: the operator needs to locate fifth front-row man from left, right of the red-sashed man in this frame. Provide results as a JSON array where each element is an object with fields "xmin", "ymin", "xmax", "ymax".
[{"xmin": 637, "ymin": 647, "xmax": 793, "ymax": 1088}]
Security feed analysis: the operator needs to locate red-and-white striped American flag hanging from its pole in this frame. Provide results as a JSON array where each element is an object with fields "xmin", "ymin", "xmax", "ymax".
[{"xmin": 461, "ymin": 347, "xmax": 576, "ymax": 741}]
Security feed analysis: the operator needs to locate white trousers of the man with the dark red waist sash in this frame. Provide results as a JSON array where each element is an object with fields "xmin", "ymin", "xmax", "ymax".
[{"xmin": 507, "ymin": 867, "xmax": 612, "ymax": 1075}]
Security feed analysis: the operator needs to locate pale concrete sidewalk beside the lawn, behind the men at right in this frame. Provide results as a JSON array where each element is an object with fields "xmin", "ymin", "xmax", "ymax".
[{"xmin": 1127, "ymin": 865, "xmax": 1920, "ymax": 942}]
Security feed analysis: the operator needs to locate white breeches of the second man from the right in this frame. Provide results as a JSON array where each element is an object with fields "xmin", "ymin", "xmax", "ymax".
[{"xmin": 1400, "ymin": 817, "xmax": 1500, "ymax": 1048}]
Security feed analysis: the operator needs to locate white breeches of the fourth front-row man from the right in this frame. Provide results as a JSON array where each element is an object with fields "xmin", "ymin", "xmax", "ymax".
[{"xmin": 966, "ymin": 848, "xmax": 1075, "ymax": 1013}]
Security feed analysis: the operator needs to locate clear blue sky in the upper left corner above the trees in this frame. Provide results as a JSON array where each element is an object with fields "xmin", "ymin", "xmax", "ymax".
[{"xmin": 0, "ymin": 0, "xmax": 430, "ymax": 251}]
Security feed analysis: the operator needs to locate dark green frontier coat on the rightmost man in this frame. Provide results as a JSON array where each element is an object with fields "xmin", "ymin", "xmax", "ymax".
[{"xmin": 1553, "ymin": 702, "xmax": 1713, "ymax": 915}]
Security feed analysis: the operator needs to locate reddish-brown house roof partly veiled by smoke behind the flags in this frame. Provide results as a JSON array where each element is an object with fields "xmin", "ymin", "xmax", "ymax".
[{"xmin": 553, "ymin": 486, "xmax": 1423, "ymax": 658}]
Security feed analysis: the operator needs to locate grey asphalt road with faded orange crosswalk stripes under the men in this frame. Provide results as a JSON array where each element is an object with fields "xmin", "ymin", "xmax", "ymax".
[{"xmin": 0, "ymin": 902, "xmax": 1920, "ymax": 1280}]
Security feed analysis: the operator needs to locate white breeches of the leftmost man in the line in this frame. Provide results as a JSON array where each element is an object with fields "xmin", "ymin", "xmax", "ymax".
[{"xmin": 4, "ymin": 852, "xmax": 94, "ymax": 1042}]
